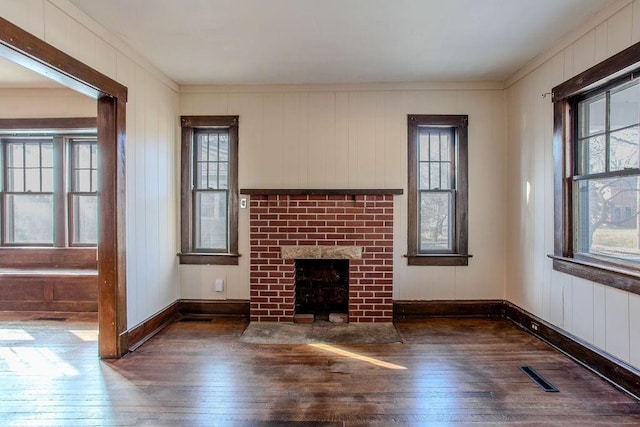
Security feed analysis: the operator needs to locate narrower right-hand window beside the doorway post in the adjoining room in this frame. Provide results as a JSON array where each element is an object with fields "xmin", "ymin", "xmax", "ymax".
[{"xmin": 68, "ymin": 139, "xmax": 98, "ymax": 246}]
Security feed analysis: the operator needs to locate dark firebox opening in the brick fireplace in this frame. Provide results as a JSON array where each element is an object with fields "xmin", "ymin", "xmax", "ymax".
[{"xmin": 295, "ymin": 259, "xmax": 349, "ymax": 320}]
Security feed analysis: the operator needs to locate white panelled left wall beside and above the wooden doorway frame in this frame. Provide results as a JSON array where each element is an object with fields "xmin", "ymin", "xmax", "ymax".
[{"xmin": 0, "ymin": 0, "xmax": 179, "ymax": 327}]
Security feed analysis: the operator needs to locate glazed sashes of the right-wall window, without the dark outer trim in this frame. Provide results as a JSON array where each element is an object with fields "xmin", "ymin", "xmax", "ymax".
[{"xmin": 572, "ymin": 81, "xmax": 640, "ymax": 263}]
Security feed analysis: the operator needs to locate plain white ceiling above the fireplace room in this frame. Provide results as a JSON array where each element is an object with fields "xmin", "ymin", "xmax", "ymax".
[{"xmin": 36, "ymin": 0, "xmax": 614, "ymax": 85}]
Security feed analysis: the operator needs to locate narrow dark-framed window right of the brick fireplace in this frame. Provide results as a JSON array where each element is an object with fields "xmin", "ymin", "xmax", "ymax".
[{"xmin": 407, "ymin": 115, "xmax": 471, "ymax": 266}]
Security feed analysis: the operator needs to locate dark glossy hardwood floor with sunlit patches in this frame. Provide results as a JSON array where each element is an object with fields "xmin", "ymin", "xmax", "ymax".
[{"xmin": 0, "ymin": 314, "xmax": 640, "ymax": 426}]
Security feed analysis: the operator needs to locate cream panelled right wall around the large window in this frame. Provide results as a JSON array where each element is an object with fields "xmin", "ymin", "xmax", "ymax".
[{"xmin": 506, "ymin": 0, "xmax": 640, "ymax": 368}]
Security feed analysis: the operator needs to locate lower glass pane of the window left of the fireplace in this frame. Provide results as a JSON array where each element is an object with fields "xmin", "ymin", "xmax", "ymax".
[{"xmin": 194, "ymin": 191, "xmax": 227, "ymax": 251}]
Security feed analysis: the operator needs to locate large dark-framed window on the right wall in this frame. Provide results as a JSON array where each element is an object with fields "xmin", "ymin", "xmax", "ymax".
[{"xmin": 552, "ymin": 40, "xmax": 640, "ymax": 293}]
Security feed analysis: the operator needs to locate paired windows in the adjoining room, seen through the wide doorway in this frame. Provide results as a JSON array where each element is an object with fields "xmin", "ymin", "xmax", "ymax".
[{"xmin": 0, "ymin": 131, "xmax": 98, "ymax": 247}]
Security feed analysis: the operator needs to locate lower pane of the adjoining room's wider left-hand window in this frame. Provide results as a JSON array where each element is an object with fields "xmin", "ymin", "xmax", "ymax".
[{"xmin": 5, "ymin": 194, "xmax": 53, "ymax": 245}]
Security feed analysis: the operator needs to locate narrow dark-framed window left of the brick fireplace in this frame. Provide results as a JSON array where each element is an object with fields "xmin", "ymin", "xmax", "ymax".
[{"xmin": 180, "ymin": 116, "xmax": 238, "ymax": 264}]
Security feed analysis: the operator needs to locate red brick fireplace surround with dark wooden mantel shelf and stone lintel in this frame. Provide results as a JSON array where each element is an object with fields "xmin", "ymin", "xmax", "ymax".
[{"xmin": 241, "ymin": 189, "xmax": 402, "ymax": 322}]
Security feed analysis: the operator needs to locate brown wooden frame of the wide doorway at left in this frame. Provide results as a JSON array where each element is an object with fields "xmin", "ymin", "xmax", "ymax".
[{"xmin": 0, "ymin": 17, "xmax": 128, "ymax": 359}]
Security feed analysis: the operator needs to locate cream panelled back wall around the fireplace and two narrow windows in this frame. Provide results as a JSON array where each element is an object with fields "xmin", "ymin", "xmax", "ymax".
[{"xmin": 179, "ymin": 83, "xmax": 506, "ymax": 300}]
